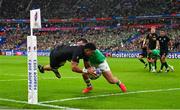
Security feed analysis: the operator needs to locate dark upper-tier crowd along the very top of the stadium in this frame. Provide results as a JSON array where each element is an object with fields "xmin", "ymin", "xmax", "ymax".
[{"xmin": 0, "ymin": 0, "xmax": 180, "ymax": 18}]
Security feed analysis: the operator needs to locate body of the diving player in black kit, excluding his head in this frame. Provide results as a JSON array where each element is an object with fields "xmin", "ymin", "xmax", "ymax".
[{"xmin": 38, "ymin": 39, "xmax": 95, "ymax": 78}]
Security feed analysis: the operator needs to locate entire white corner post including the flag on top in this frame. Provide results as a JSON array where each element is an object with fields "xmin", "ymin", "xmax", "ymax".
[{"xmin": 27, "ymin": 9, "xmax": 41, "ymax": 104}]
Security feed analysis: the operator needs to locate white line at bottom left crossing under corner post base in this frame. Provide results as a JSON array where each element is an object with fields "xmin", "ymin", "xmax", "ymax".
[{"xmin": 0, "ymin": 98, "xmax": 76, "ymax": 109}]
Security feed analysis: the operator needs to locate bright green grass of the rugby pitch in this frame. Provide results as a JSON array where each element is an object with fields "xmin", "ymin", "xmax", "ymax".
[{"xmin": 0, "ymin": 56, "xmax": 180, "ymax": 109}]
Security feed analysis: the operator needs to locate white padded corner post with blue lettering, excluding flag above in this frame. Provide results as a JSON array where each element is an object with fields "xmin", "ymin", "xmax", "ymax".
[{"xmin": 27, "ymin": 36, "xmax": 38, "ymax": 104}]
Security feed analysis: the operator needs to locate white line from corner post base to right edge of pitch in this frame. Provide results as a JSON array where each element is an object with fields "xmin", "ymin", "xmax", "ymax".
[{"xmin": 40, "ymin": 88, "xmax": 180, "ymax": 103}]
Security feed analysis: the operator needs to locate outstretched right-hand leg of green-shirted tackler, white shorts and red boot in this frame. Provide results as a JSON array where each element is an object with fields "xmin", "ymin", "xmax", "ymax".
[{"xmin": 98, "ymin": 60, "xmax": 126, "ymax": 92}]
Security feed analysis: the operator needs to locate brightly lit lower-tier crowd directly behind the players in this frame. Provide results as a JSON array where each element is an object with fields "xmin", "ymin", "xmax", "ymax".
[{"xmin": 0, "ymin": 28, "xmax": 180, "ymax": 52}]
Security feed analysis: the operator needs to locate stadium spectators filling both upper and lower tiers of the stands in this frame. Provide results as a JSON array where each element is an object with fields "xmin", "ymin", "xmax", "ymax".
[{"xmin": 0, "ymin": 0, "xmax": 180, "ymax": 51}]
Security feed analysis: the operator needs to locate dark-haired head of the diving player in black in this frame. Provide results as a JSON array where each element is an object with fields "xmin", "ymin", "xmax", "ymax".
[{"xmin": 84, "ymin": 43, "xmax": 96, "ymax": 56}]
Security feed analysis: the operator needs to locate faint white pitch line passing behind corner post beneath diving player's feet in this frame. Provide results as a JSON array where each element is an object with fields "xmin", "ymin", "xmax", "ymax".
[{"xmin": 0, "ymin": 77, "xmax": 80, "ymax": 82}]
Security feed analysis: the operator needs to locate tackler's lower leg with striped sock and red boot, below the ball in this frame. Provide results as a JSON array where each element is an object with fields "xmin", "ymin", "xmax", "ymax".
[{"xmin": 82, "ymin": 74, "xmax": 93, "ymax": 93}]
